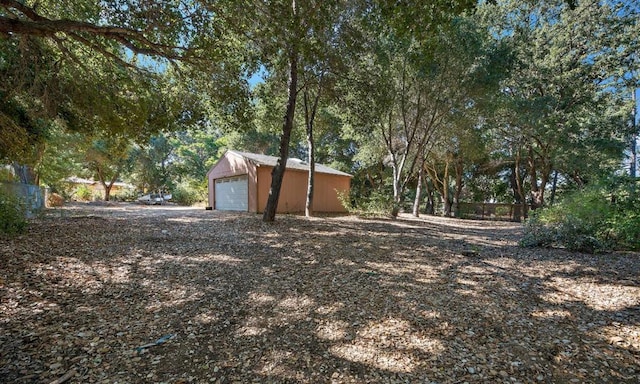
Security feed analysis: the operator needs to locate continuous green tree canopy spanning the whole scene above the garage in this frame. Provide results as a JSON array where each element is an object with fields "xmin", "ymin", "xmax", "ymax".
[{"xmin": 0, "ymin": 0, "xmax": 640, "ymax": 221}]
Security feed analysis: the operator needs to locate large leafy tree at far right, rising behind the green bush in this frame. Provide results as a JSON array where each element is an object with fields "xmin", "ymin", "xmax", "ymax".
[{"xmin": 479, "ymin": 0, "xmax": 638, "ymax": 208}]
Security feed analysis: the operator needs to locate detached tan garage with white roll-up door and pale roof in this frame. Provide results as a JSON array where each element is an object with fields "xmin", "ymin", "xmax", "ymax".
[{"xmin": 207, "ymin": 151, "xmax": 352, "ymax": 213}]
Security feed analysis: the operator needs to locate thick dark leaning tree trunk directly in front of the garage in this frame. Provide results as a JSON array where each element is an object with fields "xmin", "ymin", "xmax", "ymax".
[{"xmin": 262, "ymin": 45, "xmax": 298, "ymax": 222}]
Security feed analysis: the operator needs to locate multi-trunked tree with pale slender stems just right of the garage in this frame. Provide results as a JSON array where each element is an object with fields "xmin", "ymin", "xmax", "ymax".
[{"xmin": 350, "ymin": 11, "xmax": 500, "ymax": 215}]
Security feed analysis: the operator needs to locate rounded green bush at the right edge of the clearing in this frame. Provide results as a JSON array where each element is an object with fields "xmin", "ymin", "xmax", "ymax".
[{"xmin": 520, "ymin": 177, "xmax": 640, "ymax": 252}]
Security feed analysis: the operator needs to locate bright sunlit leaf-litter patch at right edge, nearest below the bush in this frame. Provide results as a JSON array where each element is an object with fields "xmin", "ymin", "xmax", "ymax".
[{"xmin": 542, "ymin": 277, "xmax": 640, "ymax": 311}]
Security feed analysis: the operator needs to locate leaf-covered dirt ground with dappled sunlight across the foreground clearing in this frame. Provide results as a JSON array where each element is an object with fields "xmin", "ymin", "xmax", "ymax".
[{"xmin": 0, "ymin": 204, "xmax": 640, "ymax": 384}]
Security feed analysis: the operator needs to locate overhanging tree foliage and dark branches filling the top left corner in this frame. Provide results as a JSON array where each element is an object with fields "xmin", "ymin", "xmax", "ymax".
[{"xmin": 0, "ymin": 0, "xmax": 246, "ymax": 189}]
